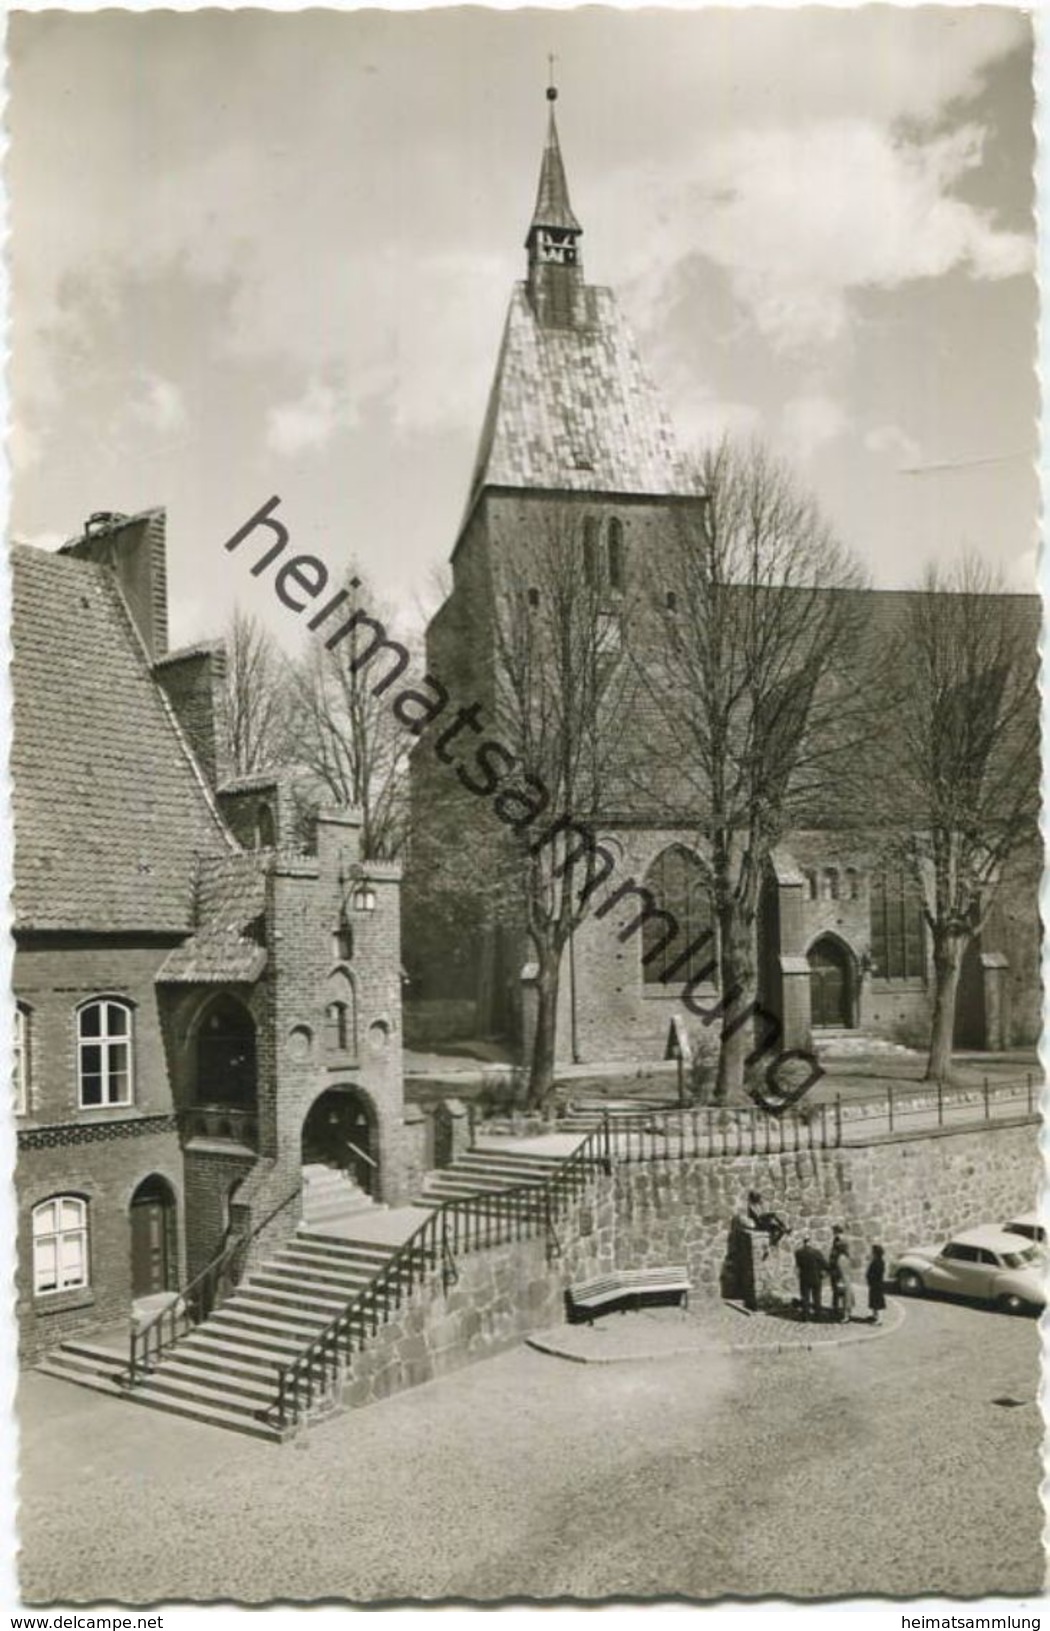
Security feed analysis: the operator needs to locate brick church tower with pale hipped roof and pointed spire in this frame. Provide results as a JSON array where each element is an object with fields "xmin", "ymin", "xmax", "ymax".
[{"xmin": 404, "ymin": 85, "xmax": 698, "ymax": 1045}]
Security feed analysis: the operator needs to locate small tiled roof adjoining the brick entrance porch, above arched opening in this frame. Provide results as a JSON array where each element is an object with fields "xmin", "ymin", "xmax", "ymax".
[{"xmin": 157, "ymin": 851, "xmax": 272, "ymax": 985}]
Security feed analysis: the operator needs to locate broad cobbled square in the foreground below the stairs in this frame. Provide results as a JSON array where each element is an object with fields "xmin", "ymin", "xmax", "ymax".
[{"xmin": 20, "ymin": 1300, "xmax": 1043, "ymax": 1605}]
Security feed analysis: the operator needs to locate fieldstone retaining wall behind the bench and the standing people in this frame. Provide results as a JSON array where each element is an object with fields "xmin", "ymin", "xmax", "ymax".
[{"xmin": 338, "ymin": 1120, "xmax": 1042, "ymax": 1406}]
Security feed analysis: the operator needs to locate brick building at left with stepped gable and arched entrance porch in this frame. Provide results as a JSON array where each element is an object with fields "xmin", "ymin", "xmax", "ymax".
[{"xmin": 11, "ymin": 511, "xmax": 404, "ymax": 1359}]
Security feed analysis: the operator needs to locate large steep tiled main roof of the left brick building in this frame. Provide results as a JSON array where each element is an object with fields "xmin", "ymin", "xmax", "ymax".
[{"xmin": 11, "ymin": 545, "xmax": 233, "ymax": 931}]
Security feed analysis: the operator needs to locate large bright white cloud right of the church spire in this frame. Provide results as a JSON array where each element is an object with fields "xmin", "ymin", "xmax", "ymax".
[{"xmin": 655, "ymin": 119, "xmax": 1034, "ymax": 351}]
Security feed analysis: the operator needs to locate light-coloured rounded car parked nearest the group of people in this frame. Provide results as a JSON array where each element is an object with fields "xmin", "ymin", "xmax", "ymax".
[{"xmin": 895, "ymin": 1223, "xmax": 1047, "ymax": 1313}]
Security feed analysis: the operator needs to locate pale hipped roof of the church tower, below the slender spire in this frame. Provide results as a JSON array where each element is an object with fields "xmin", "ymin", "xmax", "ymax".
[{"xmin": 468, "ymin": 284, "xmax": 696, "ymax": 509}]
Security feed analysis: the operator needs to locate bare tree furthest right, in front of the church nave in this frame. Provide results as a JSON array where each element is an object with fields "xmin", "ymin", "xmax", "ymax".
[{"xmin": 885, "ymin": 559, "xmax": 1039, "ymax": 1081}]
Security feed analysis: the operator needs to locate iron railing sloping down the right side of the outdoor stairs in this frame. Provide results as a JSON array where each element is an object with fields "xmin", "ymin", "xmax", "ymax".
[{"xmin": 269, "ymin": 1122, "xmax": 611, "ymax": 1430}]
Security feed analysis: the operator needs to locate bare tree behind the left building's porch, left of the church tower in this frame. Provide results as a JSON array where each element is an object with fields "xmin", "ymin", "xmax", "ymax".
[{"xmin": 290, "ymin": 568, "xmax": 411, "ymax": 860}]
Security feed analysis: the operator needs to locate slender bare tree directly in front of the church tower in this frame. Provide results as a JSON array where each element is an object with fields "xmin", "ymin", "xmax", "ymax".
[{"xmin": 494, "ymin": 506, "xmax": 636, "ymax": 1104}]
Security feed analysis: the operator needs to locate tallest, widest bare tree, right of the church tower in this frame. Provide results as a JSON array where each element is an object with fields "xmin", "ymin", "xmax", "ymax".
[{"xmin": 647, "ymin": 440, "xmax": 869, "ymax": 1096}]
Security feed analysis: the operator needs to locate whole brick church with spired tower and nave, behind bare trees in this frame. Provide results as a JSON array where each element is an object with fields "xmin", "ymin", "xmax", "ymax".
[{"xmin": 406, "ymin": 91, "xmax": 1039, "ymax": 1062}]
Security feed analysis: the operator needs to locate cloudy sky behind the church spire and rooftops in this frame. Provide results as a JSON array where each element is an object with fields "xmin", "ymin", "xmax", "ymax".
[{"xmin": 7, "ymin": 7, "xmax": 1037, "ymax": 643}]
